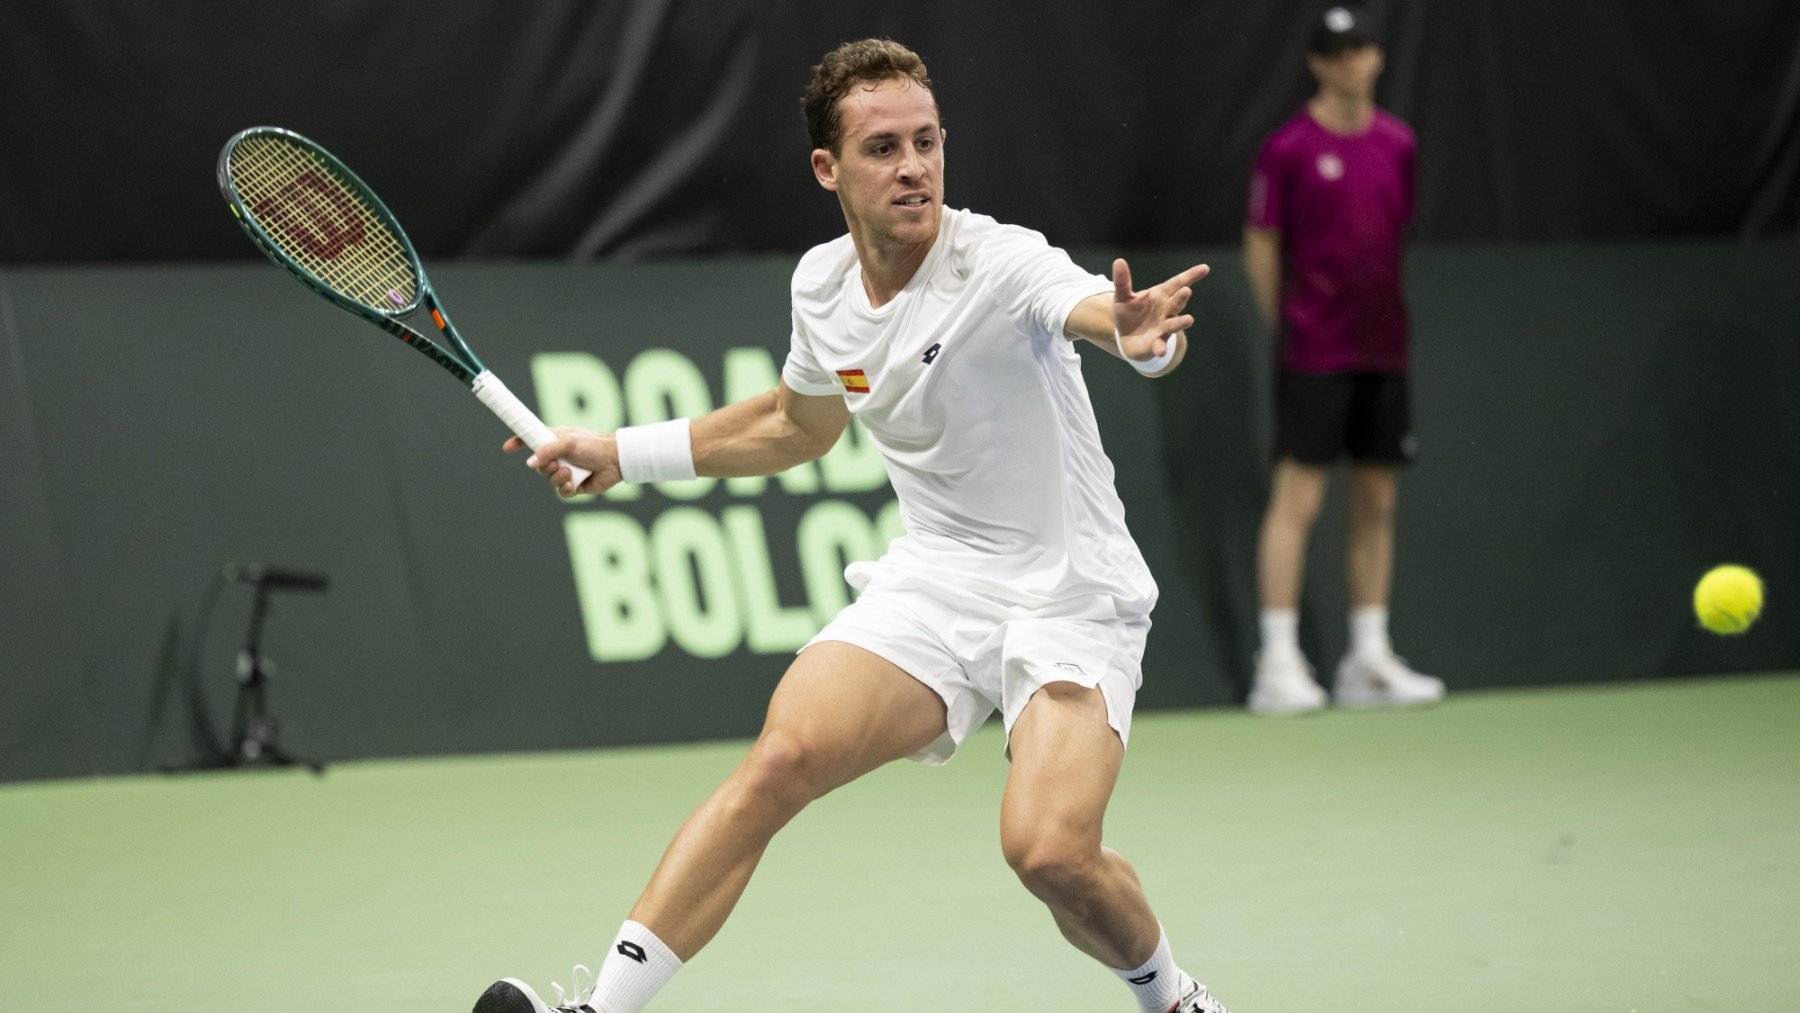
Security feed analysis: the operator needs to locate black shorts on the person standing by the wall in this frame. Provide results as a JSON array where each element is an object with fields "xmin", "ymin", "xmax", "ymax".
[{"xmin": 1274, "ymin": 367, "xmax": 1418, "ymax": 466}]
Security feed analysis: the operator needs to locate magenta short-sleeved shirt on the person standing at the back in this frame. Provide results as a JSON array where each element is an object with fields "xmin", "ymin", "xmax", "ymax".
[{"xmin": 1247, "ymin": 110, "xmax": 1417, "ymax": 372}]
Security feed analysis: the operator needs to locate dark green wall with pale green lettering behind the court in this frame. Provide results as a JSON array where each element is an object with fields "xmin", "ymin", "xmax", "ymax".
[{"xmin": 0, "ymin": 243, "xmax": 1800, "ymax": 779}]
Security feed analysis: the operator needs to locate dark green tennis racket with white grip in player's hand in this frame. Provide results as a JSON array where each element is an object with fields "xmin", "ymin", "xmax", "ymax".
[{"xmin": 218, "ymin": 126, "xmax": 589, "ymax": 486}]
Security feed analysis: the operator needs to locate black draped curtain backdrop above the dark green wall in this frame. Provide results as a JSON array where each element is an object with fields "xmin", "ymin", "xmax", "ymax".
[{"xmin": 0, "ymin": 0, "xmax": 1800, "ymax": 264}]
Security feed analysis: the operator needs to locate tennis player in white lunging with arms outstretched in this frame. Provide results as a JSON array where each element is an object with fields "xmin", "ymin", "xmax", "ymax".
[{"xmin": 475, "ymin": 40, "xmax": 1224, "ymax": 1013}]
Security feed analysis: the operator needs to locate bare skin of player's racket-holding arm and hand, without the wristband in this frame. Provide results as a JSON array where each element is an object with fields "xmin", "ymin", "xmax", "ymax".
[{"xmin": 506, "ymin": 383, "xmax": 850, "ymax": 497}]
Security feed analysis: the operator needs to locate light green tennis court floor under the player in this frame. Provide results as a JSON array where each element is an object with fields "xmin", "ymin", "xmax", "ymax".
[{"xmin": 0, "ymin": 673, "xmax": 1800, "ymax": 1013}]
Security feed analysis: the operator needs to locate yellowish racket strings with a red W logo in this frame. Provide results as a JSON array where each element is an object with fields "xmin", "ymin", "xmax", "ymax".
[{"xmin": 229, "ymin": 135, "xmax": 419, "ymax": 311}]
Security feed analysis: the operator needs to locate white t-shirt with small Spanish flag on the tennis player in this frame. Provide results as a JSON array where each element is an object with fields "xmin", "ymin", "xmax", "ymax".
[{"xmin": 781, "ymin": 209, "xmax": 1156, "ymax": 617}]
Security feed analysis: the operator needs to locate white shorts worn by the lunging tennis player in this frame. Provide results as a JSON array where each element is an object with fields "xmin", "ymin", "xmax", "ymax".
[{"xmin": 801, "ymin": 569, "xmax": 1150, "ymax": 765}]
